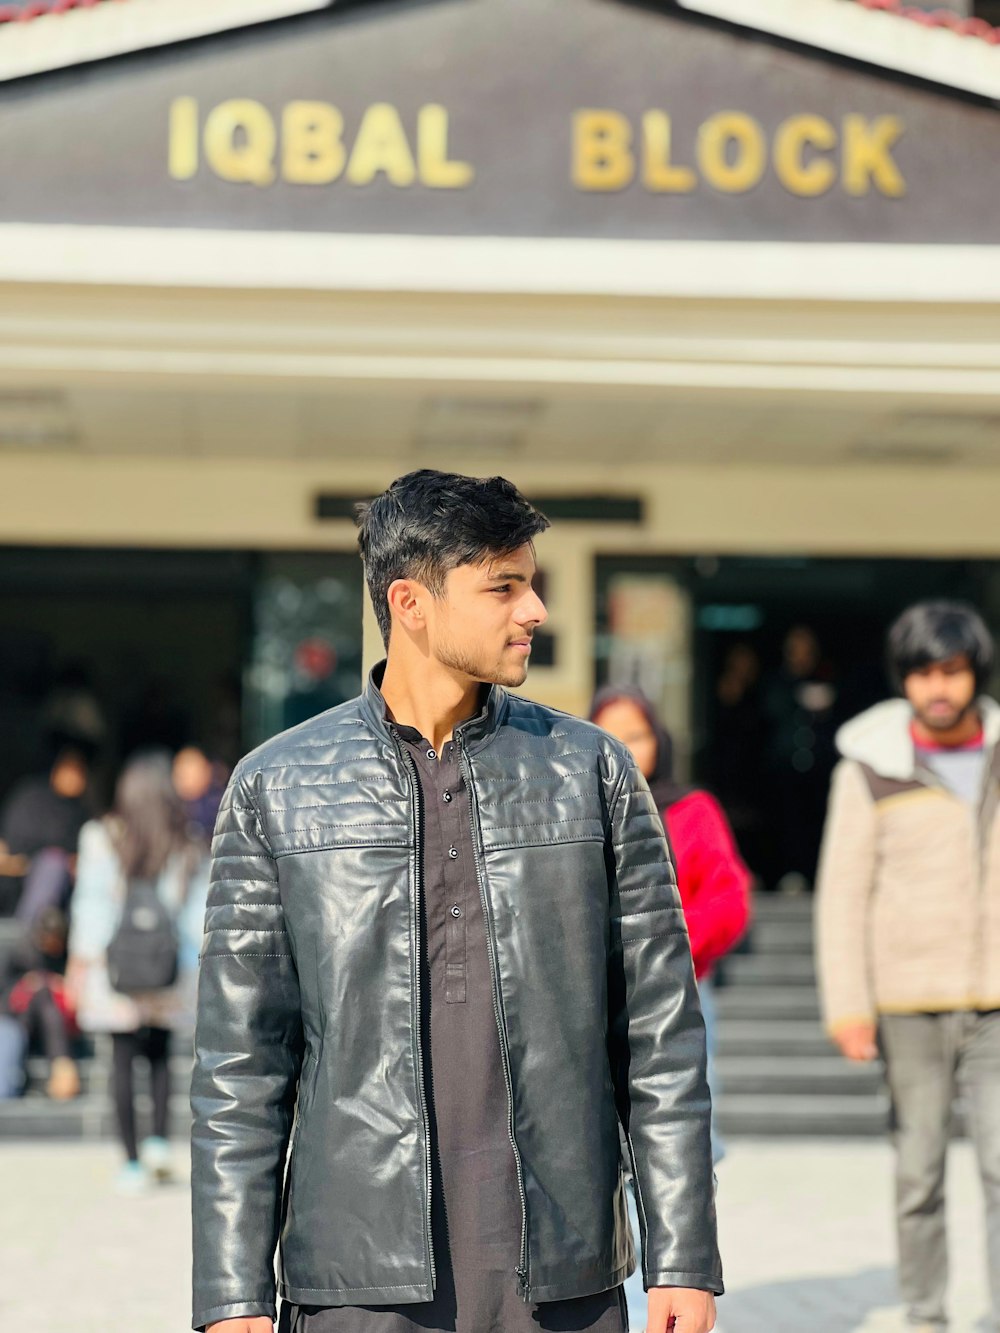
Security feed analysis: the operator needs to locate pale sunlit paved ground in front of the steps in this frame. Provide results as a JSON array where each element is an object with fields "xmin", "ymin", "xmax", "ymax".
[{"xmin": 0, "ymin": 1141, "xmax": 987, "ymax": 1333}]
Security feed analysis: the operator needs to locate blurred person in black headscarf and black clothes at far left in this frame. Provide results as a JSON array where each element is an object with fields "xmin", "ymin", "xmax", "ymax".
[{"xmin": 0, "ymin": 737, "xmax": 92, "ymax": 922}]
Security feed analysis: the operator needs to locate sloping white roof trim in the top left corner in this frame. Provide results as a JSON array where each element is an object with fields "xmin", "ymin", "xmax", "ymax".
[{"xmin": 0, "ymin": 0, "xmax": 331, "ymax": 81}]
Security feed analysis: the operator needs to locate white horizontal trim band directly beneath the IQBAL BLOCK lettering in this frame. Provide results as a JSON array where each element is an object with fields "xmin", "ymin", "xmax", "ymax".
[{"xmin": 0, "ymin": 223, "xmax": 1000, "ymax": 307}]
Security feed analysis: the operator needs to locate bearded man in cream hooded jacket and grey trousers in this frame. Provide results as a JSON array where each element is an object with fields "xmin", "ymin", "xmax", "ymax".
[{"xmin": 817, "ymin": 601, "xmax": 1000, "ymax": 1333}]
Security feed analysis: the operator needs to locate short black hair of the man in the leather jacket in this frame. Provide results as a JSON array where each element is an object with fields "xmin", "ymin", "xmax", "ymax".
[{"xmin": 357, "ymin": 468, "xmax": 549, "ymax": 648}]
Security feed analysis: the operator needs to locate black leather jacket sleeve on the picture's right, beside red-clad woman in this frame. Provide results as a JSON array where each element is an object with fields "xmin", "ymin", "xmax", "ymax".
[{"xmin": 608, "ymin": 757, "xmax": 723, "ymax": 1293}]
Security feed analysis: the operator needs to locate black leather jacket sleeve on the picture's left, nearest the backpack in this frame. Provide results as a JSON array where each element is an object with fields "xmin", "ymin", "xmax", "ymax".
[{"xmin": 191, "ymin": 770, "xmax": 303, "ymax": 1328}]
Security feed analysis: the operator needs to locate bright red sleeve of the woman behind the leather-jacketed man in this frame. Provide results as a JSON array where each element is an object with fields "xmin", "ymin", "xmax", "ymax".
[{"xmin": 667, "ymin": 792, "xmax": 751, "ymax": 976}]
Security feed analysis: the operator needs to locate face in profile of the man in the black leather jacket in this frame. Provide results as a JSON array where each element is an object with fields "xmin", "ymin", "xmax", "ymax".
[{"xmin": 425, "ymin": 545, "xmax": 548, "ymax": 686}]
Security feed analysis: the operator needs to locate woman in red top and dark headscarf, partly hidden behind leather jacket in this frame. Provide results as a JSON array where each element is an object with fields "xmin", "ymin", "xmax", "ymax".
[{"xmin": 589, "ymin": 685, "xmax": 751, "ymax": 1328}]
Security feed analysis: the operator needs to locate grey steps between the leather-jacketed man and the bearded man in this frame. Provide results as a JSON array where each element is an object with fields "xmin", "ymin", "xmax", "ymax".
[{"xmin": 716, "ymin": 894, "xmax": 888, "ymax": 1137}]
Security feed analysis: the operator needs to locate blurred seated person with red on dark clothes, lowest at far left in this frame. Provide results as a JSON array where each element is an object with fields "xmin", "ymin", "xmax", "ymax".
[{"xmin": 0, "ymin": 908, "xmax": 80, "ymax": 1101}]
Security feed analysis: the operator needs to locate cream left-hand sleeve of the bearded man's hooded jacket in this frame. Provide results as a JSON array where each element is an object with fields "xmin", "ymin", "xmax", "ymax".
[{"xmin": 816, "ymin": 760, "xmax": 877, "ymax": 1033}]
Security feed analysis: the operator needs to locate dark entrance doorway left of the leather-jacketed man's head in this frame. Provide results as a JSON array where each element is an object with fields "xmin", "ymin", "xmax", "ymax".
[{"xmin": 0, "ymin": 548, "xmax": 361, "ymax": 808}]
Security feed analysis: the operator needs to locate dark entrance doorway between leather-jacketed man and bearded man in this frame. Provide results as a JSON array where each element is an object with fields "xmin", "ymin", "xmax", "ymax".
[{"xmin": 595, "ymin": 556, "xmax": 1000, "ymax": 889}]
